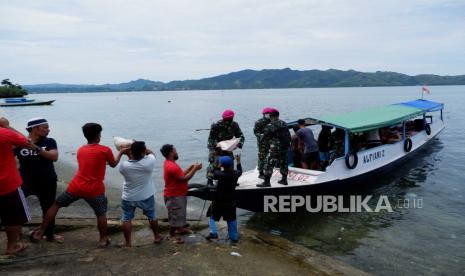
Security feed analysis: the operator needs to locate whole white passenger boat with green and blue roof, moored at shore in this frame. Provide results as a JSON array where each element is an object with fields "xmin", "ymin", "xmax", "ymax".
[{"xmin": 189, "ymin": 99, "xmax": 445, "ymax": 212}]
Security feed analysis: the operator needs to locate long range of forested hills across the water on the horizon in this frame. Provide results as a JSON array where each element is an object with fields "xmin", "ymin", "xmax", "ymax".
[{"xmin": 24, "ymin": 68, "xmax": 465, "ymax": 93}]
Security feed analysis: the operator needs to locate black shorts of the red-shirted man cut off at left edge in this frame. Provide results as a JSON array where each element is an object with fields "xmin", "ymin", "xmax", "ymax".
[{"xmin": 0, "ymin": 188, "xmax": 31, "ymax": 226}]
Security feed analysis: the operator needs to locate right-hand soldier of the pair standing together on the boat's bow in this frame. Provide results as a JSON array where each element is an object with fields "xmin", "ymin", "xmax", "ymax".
[{"xmin": 257, "ymin": 109, "xmax": 291, "ymax": 187}]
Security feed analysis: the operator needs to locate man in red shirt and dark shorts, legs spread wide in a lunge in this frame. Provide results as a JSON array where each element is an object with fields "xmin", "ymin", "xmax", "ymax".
[{"xmin": 30, "ymin": 123, "xmax": 126, "ymax": 247}]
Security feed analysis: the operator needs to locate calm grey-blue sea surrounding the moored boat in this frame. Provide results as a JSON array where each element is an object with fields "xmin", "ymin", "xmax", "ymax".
[{"xmin": 2, "ymin": 86, "xmax": 465, "ymax": 275}]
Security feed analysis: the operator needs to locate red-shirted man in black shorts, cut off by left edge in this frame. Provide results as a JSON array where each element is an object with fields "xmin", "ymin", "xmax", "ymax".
[{"xmin": 0, "ymin": 117, "xmax": 31, "ymax": 255}]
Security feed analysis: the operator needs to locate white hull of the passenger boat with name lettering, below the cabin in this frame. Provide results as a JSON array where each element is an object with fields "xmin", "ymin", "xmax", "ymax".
[{"xmin": 229, "ymin": 117, "xmax": 444, "ymax": 212}]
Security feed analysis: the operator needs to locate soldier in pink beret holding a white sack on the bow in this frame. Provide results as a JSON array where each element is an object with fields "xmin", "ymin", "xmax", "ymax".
[{"xmin": 207, "ymin": 109, "xmax": 245, "ymax": 185}]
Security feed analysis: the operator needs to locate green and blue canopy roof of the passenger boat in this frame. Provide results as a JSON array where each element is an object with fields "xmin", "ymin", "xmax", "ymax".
[{"xmin": 289, "ymin": 100, "xmax": 444, "ymax": 132}]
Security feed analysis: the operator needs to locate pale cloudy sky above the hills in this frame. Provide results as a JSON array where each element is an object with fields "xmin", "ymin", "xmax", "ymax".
[{"xmin": 0, "ymin": 0, "xmax": 465, "ymax": 84}]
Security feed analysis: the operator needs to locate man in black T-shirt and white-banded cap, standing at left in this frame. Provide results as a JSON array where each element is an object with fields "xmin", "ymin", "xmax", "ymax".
[{"xmin": 15, "ymin": 118, "xmax": 64, "ymax": 243}]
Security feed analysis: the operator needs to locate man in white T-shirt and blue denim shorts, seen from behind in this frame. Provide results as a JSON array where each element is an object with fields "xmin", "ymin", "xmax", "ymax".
[{"xmin": 119, "ymin": 141, "xmax": 161, "ymax": 247}]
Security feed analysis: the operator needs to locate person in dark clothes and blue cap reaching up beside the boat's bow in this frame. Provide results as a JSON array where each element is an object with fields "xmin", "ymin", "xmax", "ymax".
[{"xmin": 206, "ymin": 155, "xmax": 242, "ymax": 243}]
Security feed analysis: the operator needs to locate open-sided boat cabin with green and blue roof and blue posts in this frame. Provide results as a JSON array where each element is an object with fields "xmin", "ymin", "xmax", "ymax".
[{"xmin": 288, "ymin": 99, "xmax": 444, "ymax": 171}]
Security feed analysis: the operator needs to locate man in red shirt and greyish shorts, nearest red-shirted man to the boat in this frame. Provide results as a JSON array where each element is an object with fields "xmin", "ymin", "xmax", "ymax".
[{"xmin": 160, "ymin": 144, "xmax": 202, "ymax": 243}]
